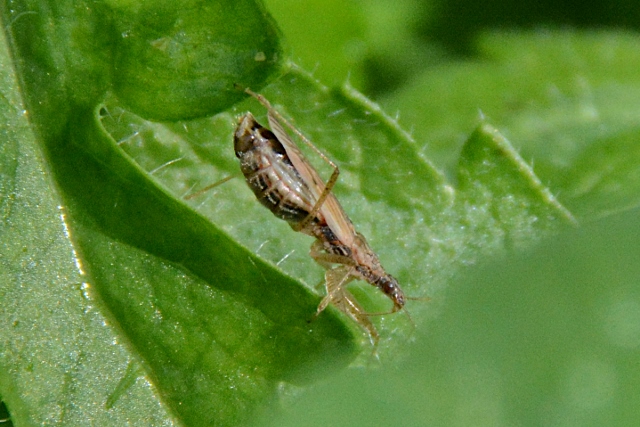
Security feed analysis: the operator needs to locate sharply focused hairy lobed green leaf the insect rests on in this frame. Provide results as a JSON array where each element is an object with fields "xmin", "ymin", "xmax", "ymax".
[{"xmin": 5, "ymin": 1, "xmax": 634, "ymax": 425}]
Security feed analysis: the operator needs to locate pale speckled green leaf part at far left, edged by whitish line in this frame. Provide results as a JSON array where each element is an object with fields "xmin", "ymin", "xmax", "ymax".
[{"xmin": 0, "ymin": 15, "xmax": 176, "ymax": 426}]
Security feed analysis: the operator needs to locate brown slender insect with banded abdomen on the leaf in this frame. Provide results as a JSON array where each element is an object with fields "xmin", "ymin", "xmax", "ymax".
[{"xmin": 234, "ymin": 89, "xmax": 406, "ymax": 347}]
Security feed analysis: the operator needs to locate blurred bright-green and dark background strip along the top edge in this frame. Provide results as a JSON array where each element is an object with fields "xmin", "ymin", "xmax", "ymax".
[{"xmin": 265, "ymin": 0, "xmax": 640, "ymax": 98}]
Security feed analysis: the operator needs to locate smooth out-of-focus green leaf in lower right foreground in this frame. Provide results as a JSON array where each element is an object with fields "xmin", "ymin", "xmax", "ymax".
[{"xmin": 263, "ymin": 209, "xmax": 640, "ymax": 427}]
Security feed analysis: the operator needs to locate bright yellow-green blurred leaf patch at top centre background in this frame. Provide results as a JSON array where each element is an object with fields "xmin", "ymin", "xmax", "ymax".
[{"xmin": 265, "ymin": 0, "xmax": 444, "ymax": 95}]
